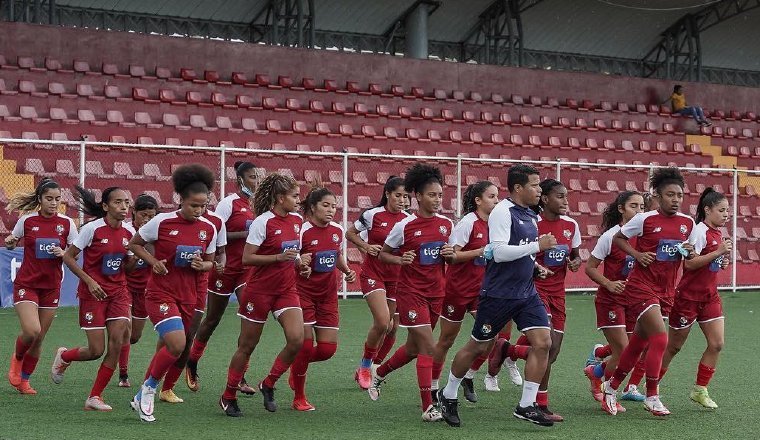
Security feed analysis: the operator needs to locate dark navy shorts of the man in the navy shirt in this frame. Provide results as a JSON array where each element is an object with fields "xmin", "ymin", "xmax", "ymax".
[{"xmin": 472, "ymin": 295, "xmax": 550, "ymax": 342}]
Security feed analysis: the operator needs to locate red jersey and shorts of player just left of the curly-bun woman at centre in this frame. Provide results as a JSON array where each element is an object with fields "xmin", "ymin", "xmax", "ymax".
[{"xmin": 354, "ymin": 206, "xmax": 409, "ymax": 281}]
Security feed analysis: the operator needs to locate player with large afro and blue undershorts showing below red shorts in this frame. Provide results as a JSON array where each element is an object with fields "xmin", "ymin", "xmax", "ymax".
[{"xmin": 129, "ymin": 164, "xmax": 216, "ymax": 422}]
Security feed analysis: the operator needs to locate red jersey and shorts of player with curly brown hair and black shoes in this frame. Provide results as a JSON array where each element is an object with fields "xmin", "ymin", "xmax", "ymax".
[{"xmin": 246, "ymin": 211, "xmax": 303, "ymax": 295}]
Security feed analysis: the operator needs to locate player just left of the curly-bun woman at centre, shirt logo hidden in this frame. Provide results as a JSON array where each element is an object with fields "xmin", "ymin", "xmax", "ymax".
[{"xmin": 346, "ymin": 176, "xmax": 409, "ymax": 390}]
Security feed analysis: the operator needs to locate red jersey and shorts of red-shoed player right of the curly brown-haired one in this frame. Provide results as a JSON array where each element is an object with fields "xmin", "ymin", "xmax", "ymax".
[{"xmin": 298, "ymin": 222, "xmax": 344, "ymax": 296}]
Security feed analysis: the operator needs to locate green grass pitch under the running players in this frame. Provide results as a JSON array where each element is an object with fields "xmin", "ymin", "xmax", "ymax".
[{"xmin": 0, "ymin": 292, "xmax": 760, "ymax": 439}]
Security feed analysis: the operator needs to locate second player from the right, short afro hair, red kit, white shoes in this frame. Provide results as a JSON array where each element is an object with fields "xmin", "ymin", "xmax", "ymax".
[{"xmin": 602, "ymin": 168, "xmax": 694, "ymax": 416}]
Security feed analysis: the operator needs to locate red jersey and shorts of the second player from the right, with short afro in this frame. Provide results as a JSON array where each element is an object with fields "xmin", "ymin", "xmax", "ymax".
[{"xmin": 620, "ymin": 211, "xmax": 694, "ymax": 297}]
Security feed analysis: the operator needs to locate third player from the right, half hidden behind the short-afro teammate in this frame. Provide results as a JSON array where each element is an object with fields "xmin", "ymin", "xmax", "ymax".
[{"xmin": 583, "ymin": 191, "xmax": 644, "ymax": 406}]
